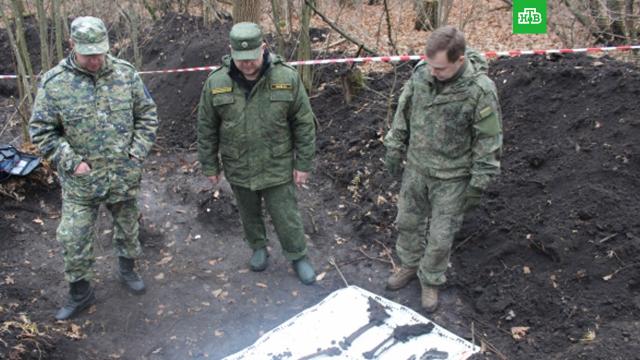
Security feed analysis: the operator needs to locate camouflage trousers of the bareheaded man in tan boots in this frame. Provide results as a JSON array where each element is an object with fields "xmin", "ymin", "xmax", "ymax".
[{"xmin": 396, "ymin": 168, "xmax": 469, "ymax": 286}]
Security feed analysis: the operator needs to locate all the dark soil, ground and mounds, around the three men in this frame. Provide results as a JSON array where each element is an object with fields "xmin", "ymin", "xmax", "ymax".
[{"xmin": 0, "ymin": 16, "xmax": 640, "ymax": 359}]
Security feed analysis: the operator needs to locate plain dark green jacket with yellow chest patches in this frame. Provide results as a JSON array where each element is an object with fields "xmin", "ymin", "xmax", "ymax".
[{"xmin": 198, "ymin": 56, "xmax": 316, "ymax": 190}]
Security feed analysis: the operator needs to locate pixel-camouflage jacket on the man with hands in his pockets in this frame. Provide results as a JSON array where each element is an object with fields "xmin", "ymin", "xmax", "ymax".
[{"xmin": 29, "ymin": 53, "xmax": 158, "ymax": 201}]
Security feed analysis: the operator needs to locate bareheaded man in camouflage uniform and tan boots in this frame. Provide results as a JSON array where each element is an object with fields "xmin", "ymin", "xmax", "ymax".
[{"xmin": 384, "ymin": 26, "xmax": 502, "ymax": 312}]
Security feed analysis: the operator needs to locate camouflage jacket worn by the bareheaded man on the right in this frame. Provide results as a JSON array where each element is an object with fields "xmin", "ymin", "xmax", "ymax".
[{"xmin": 384, "ymin": 50, "xmax": 502, "ymax": 189}]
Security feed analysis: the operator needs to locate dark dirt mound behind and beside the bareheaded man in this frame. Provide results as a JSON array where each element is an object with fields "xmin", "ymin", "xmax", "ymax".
[{"xmin": 314, "ymin": 56, "xmax": 640, "ymax": 359}]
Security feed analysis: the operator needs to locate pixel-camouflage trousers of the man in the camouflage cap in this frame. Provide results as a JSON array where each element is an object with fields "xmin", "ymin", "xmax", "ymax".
[{"xmin": 56, "ymin": 196, "xmax": 142, "ymax": 282}]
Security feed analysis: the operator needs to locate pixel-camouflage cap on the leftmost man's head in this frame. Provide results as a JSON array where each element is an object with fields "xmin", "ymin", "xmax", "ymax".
[{"xmin": 71, "ymin": 16, "xmax": 109, "ymax": 55}]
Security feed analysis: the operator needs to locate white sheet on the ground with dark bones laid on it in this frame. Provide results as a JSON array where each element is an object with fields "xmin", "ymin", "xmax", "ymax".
[{"xmin": 225, "ymin": 286, "xmax": 480, "ymax": 360}]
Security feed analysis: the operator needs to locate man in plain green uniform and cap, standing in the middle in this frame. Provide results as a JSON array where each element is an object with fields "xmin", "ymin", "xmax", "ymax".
[{"xmin": 198, "ymin": 22, "xmax": 315, "ymax": 284}]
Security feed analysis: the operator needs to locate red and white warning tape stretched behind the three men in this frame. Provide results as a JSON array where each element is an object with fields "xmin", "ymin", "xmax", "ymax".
[{"xmin": 0, "ymin": 45, "xmax": 640, "ymax": 80}]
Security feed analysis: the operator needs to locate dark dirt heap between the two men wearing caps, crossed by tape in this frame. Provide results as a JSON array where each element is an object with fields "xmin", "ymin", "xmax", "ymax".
[{"xmin": 142, "ymin": 14, "xmax": 232, "ymax": 148}]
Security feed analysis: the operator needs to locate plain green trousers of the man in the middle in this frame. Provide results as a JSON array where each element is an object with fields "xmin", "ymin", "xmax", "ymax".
[{"xmin": 231, "ymin": 182, "xmax": 307, "ymax": 261}]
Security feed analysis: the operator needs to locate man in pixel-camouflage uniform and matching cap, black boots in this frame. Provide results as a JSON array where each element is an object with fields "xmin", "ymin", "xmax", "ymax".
[{"xmin": 29, "ymin": 17, "xmax": 158, "ymax": 320}]
